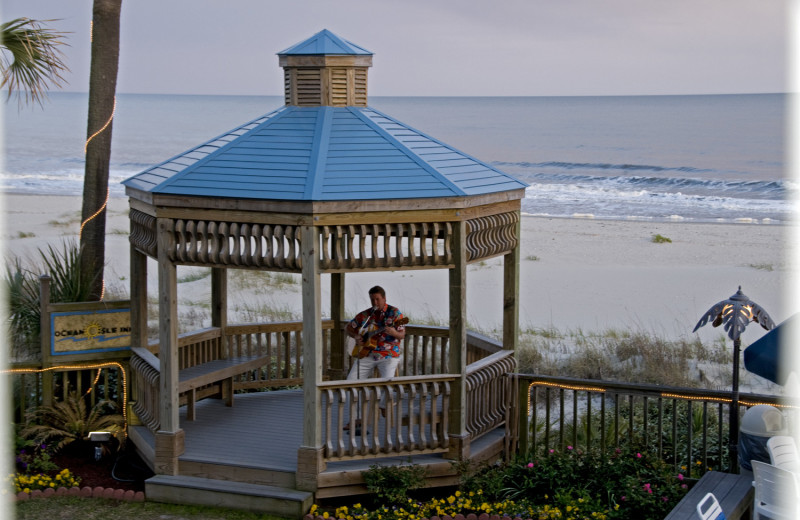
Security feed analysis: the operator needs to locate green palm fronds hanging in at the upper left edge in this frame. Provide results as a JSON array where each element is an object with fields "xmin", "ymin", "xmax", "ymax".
[{"xmin": 0, "ymin": 18, "xmax": 69, "ymax": 106}]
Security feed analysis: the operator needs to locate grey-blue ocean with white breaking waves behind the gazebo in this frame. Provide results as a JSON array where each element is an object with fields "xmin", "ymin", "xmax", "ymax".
[{"xmin": 0, "ymin": 93, "xmax": 797, "ymax": 223}]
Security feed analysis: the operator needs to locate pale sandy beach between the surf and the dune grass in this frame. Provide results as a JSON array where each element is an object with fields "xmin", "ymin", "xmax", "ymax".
[{"xmin": 3, "ymin": 195, "xmax": 796, "ymax": 343}]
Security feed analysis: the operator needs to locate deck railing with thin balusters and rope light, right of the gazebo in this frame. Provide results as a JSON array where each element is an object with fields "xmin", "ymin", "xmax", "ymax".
[{"xmin": 514, "ymin": 374, "xmax": 800, "ymax": 477}]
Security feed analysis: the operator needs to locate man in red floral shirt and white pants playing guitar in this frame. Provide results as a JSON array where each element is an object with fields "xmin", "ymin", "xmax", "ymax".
[{"xmin": 345, "ymin": 285, "xmax": 408, "ymax": 380}]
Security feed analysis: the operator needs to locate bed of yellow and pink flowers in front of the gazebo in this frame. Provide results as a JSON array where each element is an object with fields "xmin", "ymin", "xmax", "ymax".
[{"xmin": 307, "ymin": 446, "xmax": 688, "ymax": 520}]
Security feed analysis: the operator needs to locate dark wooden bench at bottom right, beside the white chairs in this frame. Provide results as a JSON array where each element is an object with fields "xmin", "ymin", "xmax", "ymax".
[{"xmin": 664, "ymin": 471, "xmax": 754, "ymax": 520}]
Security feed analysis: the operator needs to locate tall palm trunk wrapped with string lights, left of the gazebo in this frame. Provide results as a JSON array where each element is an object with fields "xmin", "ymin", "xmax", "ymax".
[{"xmin": 80, "ymin": 0, "xmax": 122, "ymax": 300}]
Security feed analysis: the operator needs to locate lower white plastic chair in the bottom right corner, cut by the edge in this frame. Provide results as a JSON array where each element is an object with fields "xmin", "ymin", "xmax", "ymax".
[{"xmin": 751, "ymin": 460, "xmax": 800, "ymax": 520}]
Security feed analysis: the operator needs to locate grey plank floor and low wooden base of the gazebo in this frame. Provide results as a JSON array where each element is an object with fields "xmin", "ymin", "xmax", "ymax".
[{"xmin": 129, "ymin": 390, "xmax": 504, "ymax": 498}]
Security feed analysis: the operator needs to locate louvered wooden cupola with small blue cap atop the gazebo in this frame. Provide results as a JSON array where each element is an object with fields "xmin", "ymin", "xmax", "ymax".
[{"xmin": 278, "ymin": 29, "xmax": 372, "ymax": 107}]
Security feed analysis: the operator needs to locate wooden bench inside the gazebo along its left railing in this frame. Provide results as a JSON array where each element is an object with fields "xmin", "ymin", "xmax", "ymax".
[{"xmin": 178, "ymin": 355, "xmax": 267, "ymax": 421}]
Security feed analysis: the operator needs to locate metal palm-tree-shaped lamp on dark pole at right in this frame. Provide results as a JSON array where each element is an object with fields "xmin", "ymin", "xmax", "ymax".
[{"xmin": 692, "ymin": 285, "xmax": 775, "ymax": 472}]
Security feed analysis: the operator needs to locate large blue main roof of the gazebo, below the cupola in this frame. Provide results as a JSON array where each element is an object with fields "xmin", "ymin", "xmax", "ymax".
[{"xmin": 123, "ymin": 106, "xmax": 527, "ymax": 201}]
